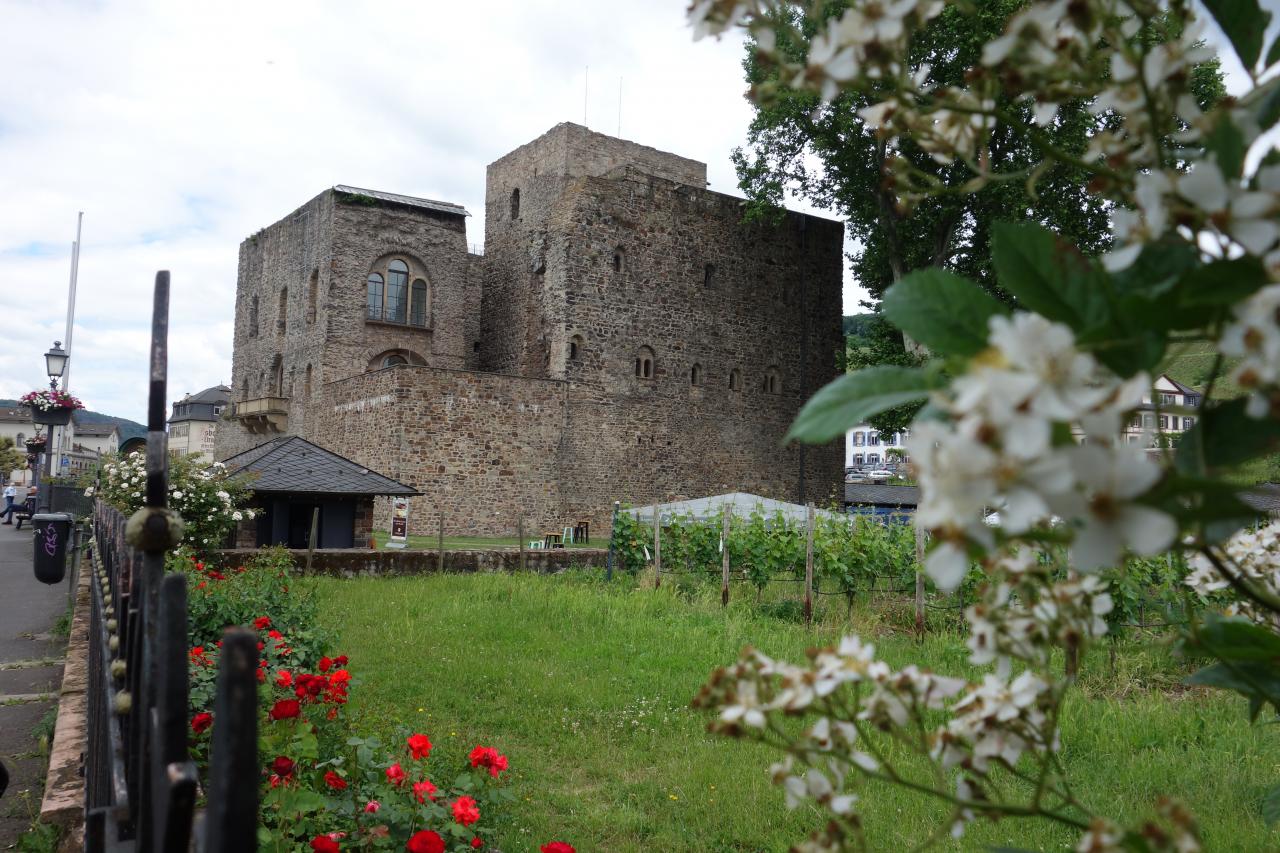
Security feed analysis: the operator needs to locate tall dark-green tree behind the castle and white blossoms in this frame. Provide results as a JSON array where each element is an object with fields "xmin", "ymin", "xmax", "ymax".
[{"xmin": 733, "ymin": 0, "xmax": 1222, "ymax": 306}]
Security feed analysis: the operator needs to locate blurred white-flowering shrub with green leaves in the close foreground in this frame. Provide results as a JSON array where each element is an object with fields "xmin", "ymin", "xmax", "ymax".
[{"xmin": 690, "ymin": 0, "xmax": 1280, "ymax": 852}]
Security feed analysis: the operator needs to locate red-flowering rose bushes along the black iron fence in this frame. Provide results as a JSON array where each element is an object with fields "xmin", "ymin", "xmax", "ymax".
[{"xmin": 183, "ymin": 548, "xmax": 573, "ymax": 853}]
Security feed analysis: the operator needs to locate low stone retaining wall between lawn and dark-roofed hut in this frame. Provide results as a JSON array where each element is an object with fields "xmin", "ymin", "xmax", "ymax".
[{"xmin": 218, "ymin": 548, "xmax": 609, "ymax": 578}]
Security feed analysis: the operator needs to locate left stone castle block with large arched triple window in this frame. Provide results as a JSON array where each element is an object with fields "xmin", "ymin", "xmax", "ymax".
[{"xmin": 216, "ymin": 190, "xmax": 483, "ymax": 459}]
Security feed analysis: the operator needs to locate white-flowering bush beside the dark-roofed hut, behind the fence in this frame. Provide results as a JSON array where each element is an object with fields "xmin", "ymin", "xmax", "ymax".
[{"xmin": 93, "ymin": 451, "xmax": 255, "ymax": 553}]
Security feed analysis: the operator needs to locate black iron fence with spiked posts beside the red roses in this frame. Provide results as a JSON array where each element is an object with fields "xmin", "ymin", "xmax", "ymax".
[{"xmin": 84, "ymin": 272, "xmax": 259, "ymax": 853}]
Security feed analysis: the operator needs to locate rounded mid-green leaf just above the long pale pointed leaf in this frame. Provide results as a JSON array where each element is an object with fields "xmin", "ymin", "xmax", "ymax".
[{"xmin": 882, "ymin": 268, "xmax": 1009, "ymax": 356}]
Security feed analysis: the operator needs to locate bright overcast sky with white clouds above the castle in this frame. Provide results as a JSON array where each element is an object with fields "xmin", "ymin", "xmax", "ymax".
[{"xmin": 0, "ymin": 0, "xmax": 1276, "ymax": 421}]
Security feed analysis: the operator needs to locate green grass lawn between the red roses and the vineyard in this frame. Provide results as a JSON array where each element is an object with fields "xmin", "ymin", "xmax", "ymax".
[{"xmin": 320, "ymin": 574, "xmax": 1280, "ymax": 853}]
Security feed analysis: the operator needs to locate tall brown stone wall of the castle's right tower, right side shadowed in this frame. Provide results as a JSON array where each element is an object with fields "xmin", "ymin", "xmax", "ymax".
[{"xmin": 548, "ymin": 170, "xmax": 844, "ymax": 523}]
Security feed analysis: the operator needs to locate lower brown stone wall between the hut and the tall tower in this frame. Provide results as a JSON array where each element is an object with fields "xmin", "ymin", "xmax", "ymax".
[{"xmin": 305, "ymin": 366, "xmax": 568, "ymax": 535}]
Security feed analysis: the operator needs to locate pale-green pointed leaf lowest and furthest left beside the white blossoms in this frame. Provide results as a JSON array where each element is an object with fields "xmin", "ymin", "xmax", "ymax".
[{"xmin": 785, "ymin": 365, "xmax": 946, "ymax": 444}]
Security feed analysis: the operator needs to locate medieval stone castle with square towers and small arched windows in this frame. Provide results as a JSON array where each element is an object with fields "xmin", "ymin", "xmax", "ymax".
[{"xmin": 215, "ymin": 123, "xmax": 844, "ymax": 535}]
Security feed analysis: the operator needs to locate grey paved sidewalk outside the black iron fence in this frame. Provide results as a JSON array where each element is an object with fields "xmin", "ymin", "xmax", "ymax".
[{"xmin": 0, "ymin": 517, "xmax": 69, "ymax": 850}]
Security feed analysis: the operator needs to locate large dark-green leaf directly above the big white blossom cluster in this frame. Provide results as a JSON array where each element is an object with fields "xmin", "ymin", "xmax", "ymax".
[{"xmin": 991, "ymin": 222, "xmax": 1111, "ymax": 336}]
